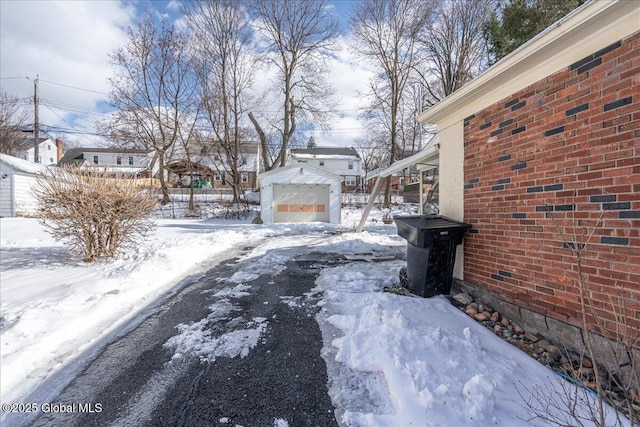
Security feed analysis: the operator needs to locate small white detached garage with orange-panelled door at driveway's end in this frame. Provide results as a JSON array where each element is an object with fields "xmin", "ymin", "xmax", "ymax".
[{"xmin": 259, "ymin": 163, "xmax": 341, "ymax": 224}]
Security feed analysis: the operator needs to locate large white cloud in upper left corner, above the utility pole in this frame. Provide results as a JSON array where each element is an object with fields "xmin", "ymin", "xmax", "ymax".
[{"xmin": 0, "ymin": 1, "xmax": 135, "ymax": 145}]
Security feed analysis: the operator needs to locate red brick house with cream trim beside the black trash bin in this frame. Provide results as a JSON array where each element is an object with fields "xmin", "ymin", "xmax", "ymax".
[{"xmin": 418, "ymin": 1, "xmax": 640, "ymax": 358}]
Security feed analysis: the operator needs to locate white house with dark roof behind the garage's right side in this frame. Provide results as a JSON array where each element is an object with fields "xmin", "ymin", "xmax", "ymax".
[{"xmin": 288, "ymin": 147, "xmax": 364, "ymax": 192}]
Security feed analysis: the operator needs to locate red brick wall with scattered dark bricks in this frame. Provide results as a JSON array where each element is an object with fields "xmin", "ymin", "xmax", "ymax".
[{"xmin": 464, "ymin": 33, "xmax": 640, "ymax": 338}]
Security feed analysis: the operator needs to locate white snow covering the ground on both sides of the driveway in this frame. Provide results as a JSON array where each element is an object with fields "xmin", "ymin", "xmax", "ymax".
[{"xmin": 0, "ymin": 206, "xmax": 620, "ymax": 427}]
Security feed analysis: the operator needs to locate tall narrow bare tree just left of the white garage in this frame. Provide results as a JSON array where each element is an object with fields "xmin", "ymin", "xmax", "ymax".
[{"xmin": 185, "ymin": 0, "xmax": 254, "ymax": 203}]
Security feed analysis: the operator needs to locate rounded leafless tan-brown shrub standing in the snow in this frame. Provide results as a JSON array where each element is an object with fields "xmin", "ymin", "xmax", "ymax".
[{"xmin": 34, "ymin": 166, "xmax": 157, "ymax": 262}]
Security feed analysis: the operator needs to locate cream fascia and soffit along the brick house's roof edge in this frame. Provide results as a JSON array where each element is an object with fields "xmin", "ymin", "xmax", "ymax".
[{"xmin": 417, "ymin": 0, "xmax": 640, "ymax": 127}]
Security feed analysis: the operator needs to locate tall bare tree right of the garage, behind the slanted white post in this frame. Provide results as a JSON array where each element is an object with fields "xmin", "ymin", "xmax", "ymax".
[{"xmin": 351, "ymin": 0, "xmax": 431, "ymax": 207}]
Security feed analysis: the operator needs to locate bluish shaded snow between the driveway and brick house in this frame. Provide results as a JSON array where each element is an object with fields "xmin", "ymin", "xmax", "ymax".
[{"xmin": 316, "ymin": 261, "xmax": 624, "ymax": 427}]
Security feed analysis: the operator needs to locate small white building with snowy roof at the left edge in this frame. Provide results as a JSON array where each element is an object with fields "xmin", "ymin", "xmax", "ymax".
[{"xmin": 0, "ymin": 154, "xmax": 47, "ymax": 217}]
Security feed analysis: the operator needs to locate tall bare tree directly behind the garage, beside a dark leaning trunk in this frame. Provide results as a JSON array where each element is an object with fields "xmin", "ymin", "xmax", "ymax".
[{"xmin": 249, "ymin": 0, "xmax": 338, "ymax": 170}]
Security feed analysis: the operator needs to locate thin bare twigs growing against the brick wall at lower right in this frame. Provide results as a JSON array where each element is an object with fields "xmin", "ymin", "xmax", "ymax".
[{"xmin": 521, "ymin": 201, "xmax": 640, "ymax": 427}]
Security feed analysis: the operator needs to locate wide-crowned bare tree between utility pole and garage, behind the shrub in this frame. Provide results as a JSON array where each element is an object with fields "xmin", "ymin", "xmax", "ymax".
[{"xmin": 99, "ymin": 16, "xmax": 196, "ymax": 204}]
